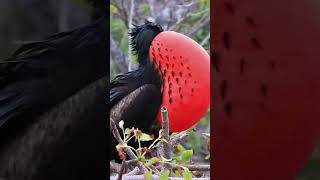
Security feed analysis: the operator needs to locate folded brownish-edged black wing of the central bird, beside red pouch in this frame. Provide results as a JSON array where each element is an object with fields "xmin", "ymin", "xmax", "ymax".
[{"xmin": 110, "ymin": 84, "xmax": 162, "ymax": 161}]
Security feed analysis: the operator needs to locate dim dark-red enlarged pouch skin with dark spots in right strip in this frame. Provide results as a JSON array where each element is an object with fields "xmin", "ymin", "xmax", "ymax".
[{"xmin": 211, "ymin": 0, "xmax": 320, "ymax": 180}]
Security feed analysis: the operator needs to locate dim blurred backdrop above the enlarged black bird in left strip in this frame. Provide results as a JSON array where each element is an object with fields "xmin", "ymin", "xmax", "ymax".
[{"xmin": 0, "ymin": 0, "xmax": 92, "ymax": 59}]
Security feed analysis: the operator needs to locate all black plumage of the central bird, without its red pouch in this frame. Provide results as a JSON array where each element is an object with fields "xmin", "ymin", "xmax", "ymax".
[{"xmin": 109, "ymin": 22, "xmax": 163, "ymax": 159}]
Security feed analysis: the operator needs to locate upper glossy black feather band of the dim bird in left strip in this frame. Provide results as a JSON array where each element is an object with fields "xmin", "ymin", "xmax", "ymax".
[{"xmin": 0, "ymin": 16, "xmax": 108, "ymax": 127}]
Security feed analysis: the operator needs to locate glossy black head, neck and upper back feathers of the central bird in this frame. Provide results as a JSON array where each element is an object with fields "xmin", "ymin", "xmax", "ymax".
[{"xmin": 109, "ymin": 22, "xmax": 163, "ymax": 107}]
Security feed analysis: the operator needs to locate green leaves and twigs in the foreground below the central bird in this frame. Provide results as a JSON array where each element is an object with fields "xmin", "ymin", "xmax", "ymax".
[{"xmin": 116, "ymin": 121, "xmax": 204, "ymax": 180}]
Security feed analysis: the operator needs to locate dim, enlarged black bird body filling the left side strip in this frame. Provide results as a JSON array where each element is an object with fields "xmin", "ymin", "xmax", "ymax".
[{"xmin": 0, "ymin": 0, "xmax": 109, "ymax": 180}]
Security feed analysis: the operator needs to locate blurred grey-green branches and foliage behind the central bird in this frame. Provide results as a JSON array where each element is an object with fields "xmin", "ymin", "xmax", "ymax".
[{"xmin": 110, "ymin": 0, "xmax": 210, "ymax": 163}]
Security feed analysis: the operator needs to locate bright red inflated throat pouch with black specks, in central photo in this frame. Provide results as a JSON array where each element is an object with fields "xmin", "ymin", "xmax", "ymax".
[{"xmin": 149, "ymin": 31, "xmax": 210, "ymax": 132}]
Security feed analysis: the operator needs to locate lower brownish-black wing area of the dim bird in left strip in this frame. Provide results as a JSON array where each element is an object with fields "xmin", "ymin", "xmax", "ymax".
[{"xmin": 0, "ymin": 77, "xmax": 109, "ymax": 180}]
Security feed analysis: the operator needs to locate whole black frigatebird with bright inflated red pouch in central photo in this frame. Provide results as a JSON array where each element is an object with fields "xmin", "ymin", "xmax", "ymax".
[{"xmin": 110, "ymin": 22, "xmax": 210, "ymax": 159}]
